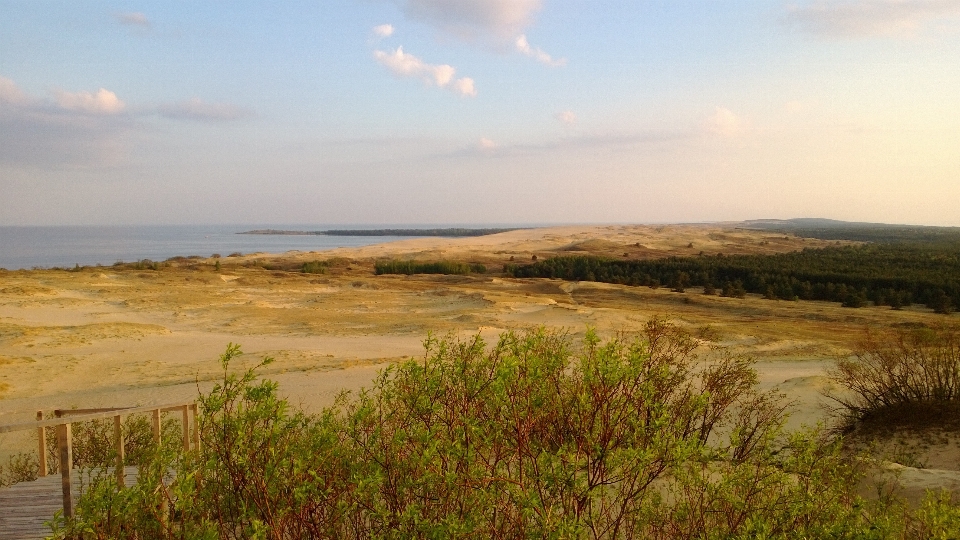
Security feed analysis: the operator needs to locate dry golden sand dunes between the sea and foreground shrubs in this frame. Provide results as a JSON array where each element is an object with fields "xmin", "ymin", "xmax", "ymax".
[{"xmin": 0, "ymin": 225, "xmax": 960, "ymax": 502}]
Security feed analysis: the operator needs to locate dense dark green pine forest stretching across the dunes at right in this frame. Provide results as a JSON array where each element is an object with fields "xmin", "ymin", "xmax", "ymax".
[{"xmin": 505, "ymin": 243, "xmax": 960, "ymax": 313}]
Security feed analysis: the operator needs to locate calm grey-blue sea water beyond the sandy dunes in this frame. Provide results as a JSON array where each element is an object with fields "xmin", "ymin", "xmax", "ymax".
[{"xmin": 0, "ymin": 225, "xmax": 420, "ymax": 270}]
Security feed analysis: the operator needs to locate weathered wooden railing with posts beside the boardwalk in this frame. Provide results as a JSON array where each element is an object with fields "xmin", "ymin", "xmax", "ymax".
[{"xmin": 0, "ymin": 401, "xmax": 200, "ymax": 517}]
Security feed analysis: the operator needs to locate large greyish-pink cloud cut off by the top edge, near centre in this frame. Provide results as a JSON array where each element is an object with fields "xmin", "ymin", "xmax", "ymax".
[{"xmin": 394, "ymin": 0, "xmax": 542, "ymax": 39}]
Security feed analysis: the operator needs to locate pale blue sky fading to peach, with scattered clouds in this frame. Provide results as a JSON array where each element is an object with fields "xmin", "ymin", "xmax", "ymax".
[{"xmin": 0, "ymin": 0, "xmax": 960, "ymax": 226}]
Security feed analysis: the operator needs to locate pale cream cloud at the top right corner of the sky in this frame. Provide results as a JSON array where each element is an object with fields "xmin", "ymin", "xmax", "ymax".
[{"xmin": 785, "ymin": 0, "xmax": 960, "ymax": 38}]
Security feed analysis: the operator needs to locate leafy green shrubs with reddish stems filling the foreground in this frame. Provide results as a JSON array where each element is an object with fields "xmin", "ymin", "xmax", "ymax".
[{"xmin": 30, "ymin": 320, "xmax": 960, "ymax": 539}]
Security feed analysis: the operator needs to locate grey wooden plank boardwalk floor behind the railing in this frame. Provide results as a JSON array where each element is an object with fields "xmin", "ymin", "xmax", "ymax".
[{"xmin": 0, "ymin": 467, "xmax": 137, "ymax": 540}]
